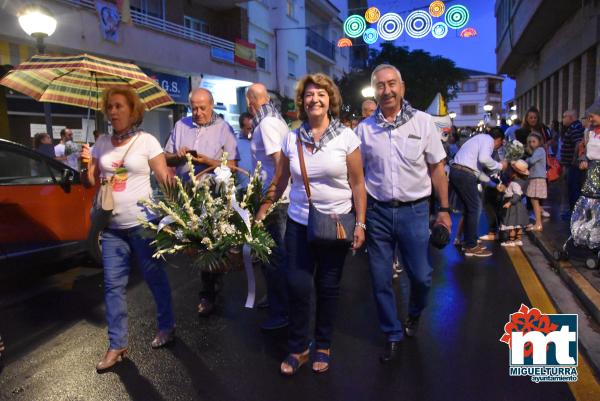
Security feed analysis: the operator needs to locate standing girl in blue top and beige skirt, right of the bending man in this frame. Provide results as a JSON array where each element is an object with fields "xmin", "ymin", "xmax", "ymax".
[{"xmin": 526, "ymin": 132, "xmax": 548, "ymax": 231}]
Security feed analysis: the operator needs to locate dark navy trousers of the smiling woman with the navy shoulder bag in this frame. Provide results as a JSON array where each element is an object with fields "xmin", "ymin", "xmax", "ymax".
[{"xmin": 285, "ymin": 218, "xmax": 350, "ymax": 353}]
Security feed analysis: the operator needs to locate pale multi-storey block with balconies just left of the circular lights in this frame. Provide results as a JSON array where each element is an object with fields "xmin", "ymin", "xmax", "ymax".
[{"xmin": 246, "ymin": 0, "xmax": 350, "ymax": 111}]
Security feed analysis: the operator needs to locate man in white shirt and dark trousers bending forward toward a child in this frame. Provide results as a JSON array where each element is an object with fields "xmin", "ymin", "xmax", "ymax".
[{"xmin": 450, "ymin": 129, "xmax": 507, "ymax": 257}]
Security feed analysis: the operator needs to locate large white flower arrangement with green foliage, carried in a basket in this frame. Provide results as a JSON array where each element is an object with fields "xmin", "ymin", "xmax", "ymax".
[{"xmin": 142, "ymin": 153, "xmax": 275, "ymax": 272}]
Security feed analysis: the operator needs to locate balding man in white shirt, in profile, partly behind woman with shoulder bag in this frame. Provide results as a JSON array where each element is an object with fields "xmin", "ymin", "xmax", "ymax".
[{"xmin": 246, "ymin": 83, "xmax": 289, "ymax": 330}]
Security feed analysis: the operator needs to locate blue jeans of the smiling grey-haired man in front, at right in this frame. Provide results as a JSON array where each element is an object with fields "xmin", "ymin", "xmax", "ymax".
[{"xmin": 367, "ymin": 197, "xmax": 433, "ymax": 341}]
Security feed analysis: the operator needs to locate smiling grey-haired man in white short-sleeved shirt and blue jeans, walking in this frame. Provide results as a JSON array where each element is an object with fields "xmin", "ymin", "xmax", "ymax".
[{"xmin": 356, "ymin": 64, "xmax": 452, "ymax": 363}]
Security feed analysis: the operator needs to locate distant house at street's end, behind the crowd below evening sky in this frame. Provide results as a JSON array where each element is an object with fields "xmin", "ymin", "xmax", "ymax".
[{"xmin": 448, "ymin": 68, "xmax": 504, "ymax": 127}]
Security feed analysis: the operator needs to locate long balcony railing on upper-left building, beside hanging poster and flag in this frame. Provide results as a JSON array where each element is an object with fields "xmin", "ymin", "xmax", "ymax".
[{"xmin": 56, "ymin": 0, "xmax": 235, "ymax": 51}]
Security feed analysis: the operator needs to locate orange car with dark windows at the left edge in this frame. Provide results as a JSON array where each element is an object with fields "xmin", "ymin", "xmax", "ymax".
[{"xmin": 0, "ymin": 139, "xmax": 101, "ymax": 271}]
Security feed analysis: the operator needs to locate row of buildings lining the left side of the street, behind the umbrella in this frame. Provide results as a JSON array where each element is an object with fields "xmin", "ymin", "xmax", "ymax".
[{"xmin": 0, "ymin": 0, "xmax": 349, "ymax": 145}]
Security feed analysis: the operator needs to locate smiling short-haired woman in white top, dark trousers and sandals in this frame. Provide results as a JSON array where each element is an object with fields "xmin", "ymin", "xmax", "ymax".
[{"xmin": 257, "ymin": 74, "xmax": 366, "ymax": 375}]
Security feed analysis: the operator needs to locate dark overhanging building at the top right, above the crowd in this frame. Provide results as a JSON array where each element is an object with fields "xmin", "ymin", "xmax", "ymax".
[{"xmin": 495, "ymin": 0, "xmax": 600, "ymax": 124}]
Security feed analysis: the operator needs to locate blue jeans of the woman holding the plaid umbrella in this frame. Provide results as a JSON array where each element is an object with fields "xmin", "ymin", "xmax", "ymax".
[{"xmin": 102, "ymin": 226, "xmax": 175, "ymax": 349}]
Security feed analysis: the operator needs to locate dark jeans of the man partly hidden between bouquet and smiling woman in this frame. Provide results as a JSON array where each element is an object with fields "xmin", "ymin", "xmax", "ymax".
[{"xmin": 263, "ymin": 203, "xmax": 289, "ymax": 319}]
